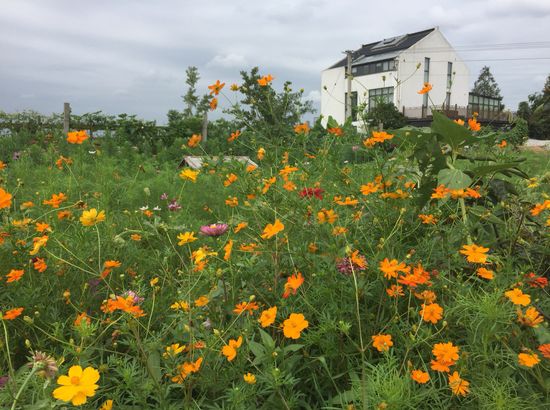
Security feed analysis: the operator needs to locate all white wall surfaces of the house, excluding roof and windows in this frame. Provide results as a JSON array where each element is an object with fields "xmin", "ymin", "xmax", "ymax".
[{"xmin": 321, "ymin": 29, "xmax": 470, "ymax": 125}]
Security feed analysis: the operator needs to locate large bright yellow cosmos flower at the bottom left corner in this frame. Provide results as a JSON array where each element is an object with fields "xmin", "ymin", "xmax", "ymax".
[{"xmin": 53, "ymin": 366, "xmax": 99, "ymax": 406}]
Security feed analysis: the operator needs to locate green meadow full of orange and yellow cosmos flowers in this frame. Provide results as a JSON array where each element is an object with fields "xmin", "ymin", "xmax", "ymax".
[{"xmin": 0, "ymin": 71, "xmax": 550, "ymax": 410}]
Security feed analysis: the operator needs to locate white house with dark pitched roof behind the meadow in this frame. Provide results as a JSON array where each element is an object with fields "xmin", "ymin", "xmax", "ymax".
[{"xmin": 321, "ymin": 27, "xmax": 470, "ymax": 123}]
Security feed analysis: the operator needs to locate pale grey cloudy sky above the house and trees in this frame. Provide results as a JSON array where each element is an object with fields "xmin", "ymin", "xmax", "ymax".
[{"xmin": 0, "ymin": 0, "xmax": 550, "ymax": 123}]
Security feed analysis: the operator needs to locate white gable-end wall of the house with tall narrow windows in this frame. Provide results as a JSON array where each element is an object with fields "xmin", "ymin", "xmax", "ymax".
[{"xmin": 396, "ymin": 30, "xmax": 470, "ymax": 116}]
